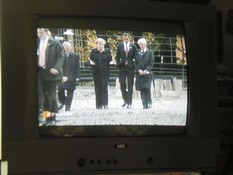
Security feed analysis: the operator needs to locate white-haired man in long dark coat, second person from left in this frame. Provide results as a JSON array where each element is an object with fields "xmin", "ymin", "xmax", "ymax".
[{"xmin": 58, "ymin": 41, "xmax": 81, "ymax": 111}]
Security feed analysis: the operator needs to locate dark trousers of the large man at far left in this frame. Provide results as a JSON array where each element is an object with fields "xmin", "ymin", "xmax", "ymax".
[{"xmin": 38, "ymin": 77, "xmax": 58, "ymax": 113}]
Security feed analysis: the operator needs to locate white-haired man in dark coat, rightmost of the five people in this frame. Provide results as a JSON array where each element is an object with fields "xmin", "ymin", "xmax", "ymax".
[{"xmin": 135, "ymin": 38, "xmax": 154, "ymax": 109}]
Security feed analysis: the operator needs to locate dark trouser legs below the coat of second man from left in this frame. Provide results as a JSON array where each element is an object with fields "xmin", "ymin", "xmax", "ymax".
[{"xmin": 58, "ymin": 87, "xmax": 74, "ymax": 110}]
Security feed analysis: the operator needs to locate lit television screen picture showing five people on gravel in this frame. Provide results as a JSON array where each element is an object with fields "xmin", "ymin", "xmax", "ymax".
[{"xmin": 37, "ymin": 28, "xmax": 188, "ymax": 137}]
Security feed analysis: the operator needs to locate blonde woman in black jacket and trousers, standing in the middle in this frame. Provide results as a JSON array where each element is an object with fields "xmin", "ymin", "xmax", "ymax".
[{"xmin": 90, "ymin": 38, "xmax": 112, "ymax": 109}]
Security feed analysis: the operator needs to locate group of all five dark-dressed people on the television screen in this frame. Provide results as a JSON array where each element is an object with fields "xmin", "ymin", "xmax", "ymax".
[{"xmin": 37, "ymin": 28, "xmax": 154, "ymax": 122}]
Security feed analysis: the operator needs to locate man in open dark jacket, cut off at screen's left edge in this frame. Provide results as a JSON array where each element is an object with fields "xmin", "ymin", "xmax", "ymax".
[{"xmin": 37, "ymin": 28, "xmax": 65, "ymax": 122}]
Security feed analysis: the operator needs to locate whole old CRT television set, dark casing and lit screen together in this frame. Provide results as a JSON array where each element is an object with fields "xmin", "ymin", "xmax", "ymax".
[{"xmin": 1, "ymin": 0, "xmax": 219, "ymax": 175}]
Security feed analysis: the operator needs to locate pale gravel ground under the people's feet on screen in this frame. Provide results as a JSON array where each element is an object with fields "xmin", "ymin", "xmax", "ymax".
[{"xmin": 40, "ymin": 87, "xmax": 187, "ymax": 126}]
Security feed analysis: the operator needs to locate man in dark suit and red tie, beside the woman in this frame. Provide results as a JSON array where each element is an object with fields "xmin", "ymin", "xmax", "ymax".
[{"xmin": 116, "ymin": 33, "xmax": 137, "ymax": 108}]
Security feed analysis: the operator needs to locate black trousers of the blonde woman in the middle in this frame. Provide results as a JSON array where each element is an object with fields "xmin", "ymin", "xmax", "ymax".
[{"xmin": 93, "ymin": 74, "xmax": 109, "ymax": 109}]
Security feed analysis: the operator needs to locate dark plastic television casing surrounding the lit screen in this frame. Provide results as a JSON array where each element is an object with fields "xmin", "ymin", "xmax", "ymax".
[{"xmin": 1, "ymin": 0, "xmax": 219, "ymax": 174}]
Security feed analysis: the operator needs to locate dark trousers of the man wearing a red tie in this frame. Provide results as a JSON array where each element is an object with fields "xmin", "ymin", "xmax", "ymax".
[{"xmin": 119, "ymin": 68, "xmax": 134, "ymax": 105}]
